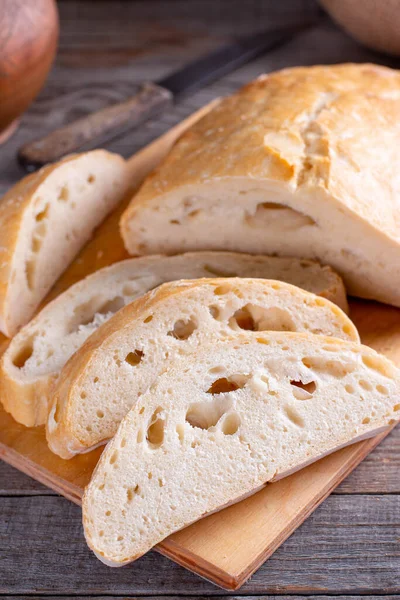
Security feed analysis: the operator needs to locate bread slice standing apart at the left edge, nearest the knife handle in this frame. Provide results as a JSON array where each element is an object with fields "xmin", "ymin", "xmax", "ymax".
[{"xmin": 0, "ymin": 150, "xmax": 129, "ymax": 336}]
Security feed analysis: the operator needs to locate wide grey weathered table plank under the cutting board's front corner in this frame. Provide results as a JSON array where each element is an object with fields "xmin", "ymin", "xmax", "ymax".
[{"xmin": 0, "ymin": 495, "xmax": 400, "ymax": 595}]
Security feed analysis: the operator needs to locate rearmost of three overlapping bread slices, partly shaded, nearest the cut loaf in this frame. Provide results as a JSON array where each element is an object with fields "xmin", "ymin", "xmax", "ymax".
[{"xmin": 0, "ymin": 252, "xmax": 347, "ymax": 427}]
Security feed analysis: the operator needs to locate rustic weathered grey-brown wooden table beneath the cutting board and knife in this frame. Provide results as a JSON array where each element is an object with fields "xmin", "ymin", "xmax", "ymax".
[{"xmin": 0, "ymin": 0, "xmax": 400, "ymax": 599}]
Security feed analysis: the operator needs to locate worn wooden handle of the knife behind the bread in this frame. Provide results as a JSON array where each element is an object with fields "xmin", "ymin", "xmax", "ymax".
[{"xmin": 18, "ymin": 83, "xmax": 173, "ymax": 171}]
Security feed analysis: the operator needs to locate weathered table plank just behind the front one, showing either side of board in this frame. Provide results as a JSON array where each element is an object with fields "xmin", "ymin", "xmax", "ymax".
[{"xmin": 0, "ymin": 427, "xmax": 400, "ymax": 496}]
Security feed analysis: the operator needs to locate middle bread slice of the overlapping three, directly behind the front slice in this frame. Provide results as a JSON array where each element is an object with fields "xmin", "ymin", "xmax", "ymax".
[{"xmin": 47, "ymin": 278, "xmax": 359, "ymax": 458}]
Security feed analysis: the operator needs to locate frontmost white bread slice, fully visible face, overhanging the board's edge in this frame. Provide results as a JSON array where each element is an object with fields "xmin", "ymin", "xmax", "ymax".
[{"xmin": 83, "ymin": 332, "xmax": 400, "ymax": 566}]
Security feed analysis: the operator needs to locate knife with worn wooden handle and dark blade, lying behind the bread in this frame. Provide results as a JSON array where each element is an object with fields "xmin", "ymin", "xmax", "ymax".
[{"xmin": 18, "ymin": 24, "xmax": 305, "ymax": 171}]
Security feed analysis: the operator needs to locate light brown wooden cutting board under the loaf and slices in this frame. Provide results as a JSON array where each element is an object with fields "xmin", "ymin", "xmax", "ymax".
[{"xmin": 0, "ymin": 105, "xmax": 400, "ymax": 590}]
